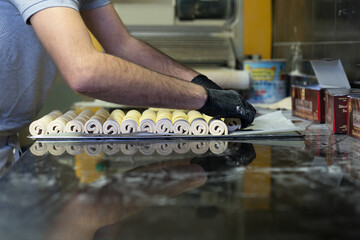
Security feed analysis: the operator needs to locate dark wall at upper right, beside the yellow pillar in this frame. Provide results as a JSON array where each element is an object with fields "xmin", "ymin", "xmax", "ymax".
[{"xmin": 273, "ymin": 0, "xmax": 360, "ymax": 83}]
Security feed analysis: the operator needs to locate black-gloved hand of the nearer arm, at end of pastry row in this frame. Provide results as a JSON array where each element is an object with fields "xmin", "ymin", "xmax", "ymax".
[{"xmin": 199, "ymin": 88, "xmax": 256, "ymax": 128}]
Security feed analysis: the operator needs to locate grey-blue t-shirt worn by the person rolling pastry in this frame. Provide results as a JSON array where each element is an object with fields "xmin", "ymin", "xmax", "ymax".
[{"xmin": 0, "ymin": 0, "xmax": 110, "ymax": 137}]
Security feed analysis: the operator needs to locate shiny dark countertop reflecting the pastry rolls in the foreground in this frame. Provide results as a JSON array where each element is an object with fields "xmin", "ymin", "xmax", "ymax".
[{"xmin": 0, "ymin": 111, "xmax": 360, "ymax": 240}]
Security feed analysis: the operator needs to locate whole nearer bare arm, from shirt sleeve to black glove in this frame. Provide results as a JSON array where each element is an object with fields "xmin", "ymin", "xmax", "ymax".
[{"xmin": 30, "ymin": 7, "xmax": 207, "ymax": 109}]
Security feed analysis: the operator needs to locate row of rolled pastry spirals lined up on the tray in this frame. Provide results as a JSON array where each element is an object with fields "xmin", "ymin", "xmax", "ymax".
[{"xmin": 30, "ymin": 108, "xmax": 241, "ymax": 135}]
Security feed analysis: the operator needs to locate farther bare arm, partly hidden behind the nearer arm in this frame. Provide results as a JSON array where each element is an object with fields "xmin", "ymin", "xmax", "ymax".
[{"xmin": 81, "ymin": 4, "xmax": 199, "ymax": 81}]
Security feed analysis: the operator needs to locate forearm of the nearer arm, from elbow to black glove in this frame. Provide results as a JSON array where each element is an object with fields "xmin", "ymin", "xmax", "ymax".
[{"xmin": 71, "ymin": 53, "xmax": 206, "ymax": 109}]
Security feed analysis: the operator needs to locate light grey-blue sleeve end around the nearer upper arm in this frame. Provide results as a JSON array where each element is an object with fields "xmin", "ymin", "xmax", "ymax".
[{"xmin": 10, "ymin": 0, "xmax": 80, "ymax": 24}]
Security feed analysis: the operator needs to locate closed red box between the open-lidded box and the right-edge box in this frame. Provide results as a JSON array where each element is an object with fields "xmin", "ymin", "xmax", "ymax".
[{"xmin": 325, "ymin": 88, "xmax": 360, "ymax": 133}]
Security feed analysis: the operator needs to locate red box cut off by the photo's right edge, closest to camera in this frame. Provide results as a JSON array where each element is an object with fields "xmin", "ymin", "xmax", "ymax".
[{"xmin": 347, "ymin": 95, "xmax": 360, "ymax": 139}]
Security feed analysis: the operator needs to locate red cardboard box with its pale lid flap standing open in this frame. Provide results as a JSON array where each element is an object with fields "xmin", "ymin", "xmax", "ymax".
[{"xmin": 291, "ymin": 60, "xmax": 350, "ymax": 123}]
